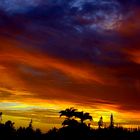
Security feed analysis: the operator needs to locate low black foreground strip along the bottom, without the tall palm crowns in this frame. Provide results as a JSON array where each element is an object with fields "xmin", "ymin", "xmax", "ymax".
[{"xmin": 0, "ymin": 121, "xmax": 140, "ymax": 140}]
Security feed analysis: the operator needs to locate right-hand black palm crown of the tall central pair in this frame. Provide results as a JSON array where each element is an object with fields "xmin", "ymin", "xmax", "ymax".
[{"xmin": 75, "ymin": 111, "xmax": 92, "ymax": 123}]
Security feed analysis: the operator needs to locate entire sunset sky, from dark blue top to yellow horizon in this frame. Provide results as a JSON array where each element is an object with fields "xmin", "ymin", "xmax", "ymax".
[{"xmin": 0, "ymin": 0, "xmax": 140, "ymax": 130}]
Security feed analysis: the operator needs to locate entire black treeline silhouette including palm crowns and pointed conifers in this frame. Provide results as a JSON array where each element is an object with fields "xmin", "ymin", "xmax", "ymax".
[{"xmin": 0, "ymin": 108, "xmax": 140, "ymax": 140}]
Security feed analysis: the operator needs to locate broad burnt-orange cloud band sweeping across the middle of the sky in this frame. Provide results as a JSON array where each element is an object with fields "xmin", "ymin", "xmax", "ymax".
[{"xmin": 0, "ymin": 34, "xmax": 139, "ymax": 110}]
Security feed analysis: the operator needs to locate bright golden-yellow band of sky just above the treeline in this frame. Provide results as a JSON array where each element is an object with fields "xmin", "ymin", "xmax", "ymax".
[{"xmin": 0, "ymin": 99, "xmax": 140, "ymax": 132}]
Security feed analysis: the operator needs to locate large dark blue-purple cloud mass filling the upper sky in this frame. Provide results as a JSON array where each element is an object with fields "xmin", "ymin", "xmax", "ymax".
[{"xmin": 0, "ymin": 0, "xmax": 139, "ymax": 65}]
